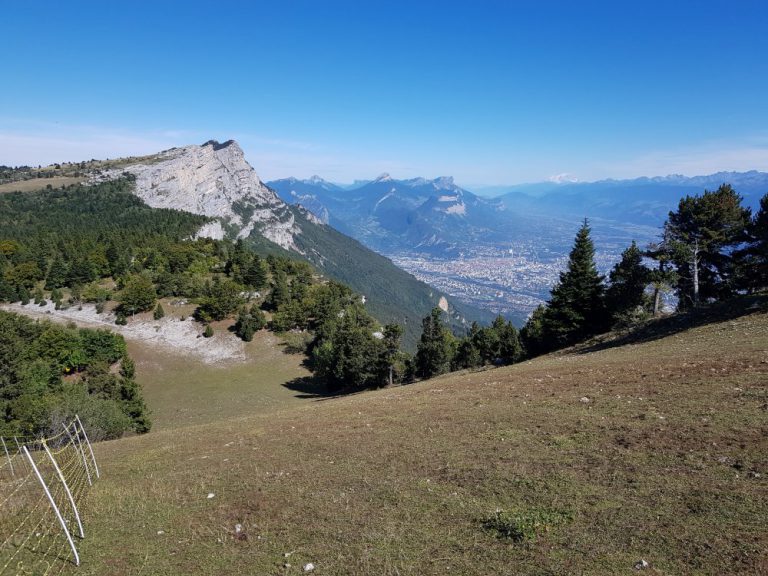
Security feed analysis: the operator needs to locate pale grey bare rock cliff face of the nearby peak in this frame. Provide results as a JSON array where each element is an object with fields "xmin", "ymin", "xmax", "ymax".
[{"xmin": 94, "ymin": 140, "xmax": 301, "ymax": 252}]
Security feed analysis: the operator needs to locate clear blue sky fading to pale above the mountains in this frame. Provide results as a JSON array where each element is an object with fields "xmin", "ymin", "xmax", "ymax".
[{"xmin": 0, "ymin": 0, "xmax": 768, "ymax": 186}]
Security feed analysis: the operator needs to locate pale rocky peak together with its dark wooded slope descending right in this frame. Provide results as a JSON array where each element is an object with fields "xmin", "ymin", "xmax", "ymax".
[{"xmin": 84, "ymin": 140, "xmax": 492, "ymax": 350}]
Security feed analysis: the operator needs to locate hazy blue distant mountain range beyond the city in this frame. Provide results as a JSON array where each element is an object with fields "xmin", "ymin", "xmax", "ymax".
[{"xmin": 267, "ymin": 171, "xmax": 768, "ymax": 257}]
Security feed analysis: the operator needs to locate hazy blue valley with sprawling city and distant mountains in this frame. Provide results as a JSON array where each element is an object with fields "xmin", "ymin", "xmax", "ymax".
[{"xmin": 267, "ymin": 171, "xmax": 768, "ymax": 323}]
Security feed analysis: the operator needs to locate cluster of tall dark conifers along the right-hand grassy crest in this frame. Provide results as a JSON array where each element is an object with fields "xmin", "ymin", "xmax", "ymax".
[{"xmin": 521, "ymin": 184, "xmax": 768, "ymax": 356}]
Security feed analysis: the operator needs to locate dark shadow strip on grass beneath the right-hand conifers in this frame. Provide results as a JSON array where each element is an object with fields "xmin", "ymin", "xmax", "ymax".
[{"xmin": 575, "ymin": 295, "xmax": 768, "ymax": 354}]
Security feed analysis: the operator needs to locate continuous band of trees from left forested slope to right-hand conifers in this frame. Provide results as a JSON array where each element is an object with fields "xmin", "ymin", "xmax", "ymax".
[{"xmin": 0, "ymin": 178, "xmax": 768, "ymax": 400}]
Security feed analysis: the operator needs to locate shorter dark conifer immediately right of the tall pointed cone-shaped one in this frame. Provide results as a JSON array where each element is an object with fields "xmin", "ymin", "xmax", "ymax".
[{"xmin": 605, "ymin": 241, "xmax": 650, "ymax": 322}]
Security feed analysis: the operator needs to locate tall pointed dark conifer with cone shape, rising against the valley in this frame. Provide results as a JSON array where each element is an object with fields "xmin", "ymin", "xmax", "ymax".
[{"xmin": 544, "ymin": 219, "xmax": 606, "ymax": 348}]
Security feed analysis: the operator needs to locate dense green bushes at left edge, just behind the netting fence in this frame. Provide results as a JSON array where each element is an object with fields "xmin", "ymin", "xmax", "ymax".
[{"xmin": 0, "ymin": 311, "xmax": 151, "ymax": 439}]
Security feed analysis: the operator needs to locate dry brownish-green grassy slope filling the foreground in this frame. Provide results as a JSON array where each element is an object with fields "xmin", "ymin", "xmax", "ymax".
[{"xmin": 73, "ymin": 302, "xmax": 768, "ymax": 575}]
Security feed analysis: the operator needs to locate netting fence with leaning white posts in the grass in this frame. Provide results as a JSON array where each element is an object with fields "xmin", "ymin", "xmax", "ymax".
[{"xmin": 0, "ymin": 416, "xmax": 99, "ymax": 576}]
